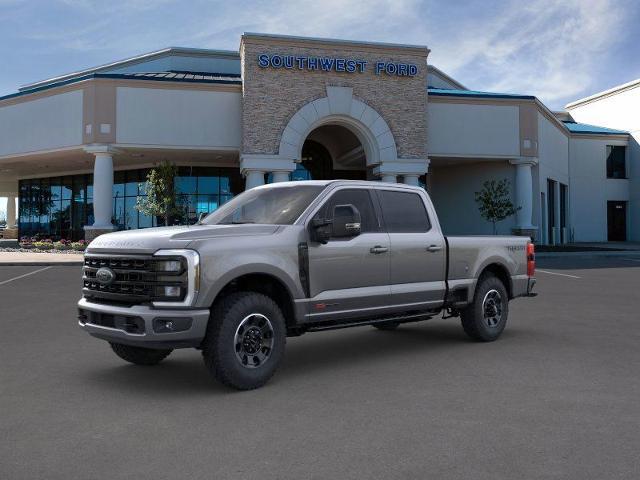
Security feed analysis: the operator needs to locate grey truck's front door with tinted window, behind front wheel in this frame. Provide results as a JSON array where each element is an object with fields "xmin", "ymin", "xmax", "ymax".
[{"xmin": 308, "ymin": 188, "xmax": 391, "ymax": 322}]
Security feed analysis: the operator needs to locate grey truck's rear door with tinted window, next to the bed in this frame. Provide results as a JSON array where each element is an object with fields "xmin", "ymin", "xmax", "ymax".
[{"xmin": 376, "ymin": 189, "xmax": 446, "ymax": 310}]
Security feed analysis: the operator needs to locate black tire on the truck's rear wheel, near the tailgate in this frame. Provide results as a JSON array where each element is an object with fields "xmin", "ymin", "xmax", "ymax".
[{"xmin": 460, "ymin": 274, "xmax": 509, "ymax": 342}]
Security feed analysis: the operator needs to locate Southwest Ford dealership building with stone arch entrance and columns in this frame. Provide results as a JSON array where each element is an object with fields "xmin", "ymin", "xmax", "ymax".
[{"xmin": 0, "ymin": 33, "xmax": 640, "ymax": 244}]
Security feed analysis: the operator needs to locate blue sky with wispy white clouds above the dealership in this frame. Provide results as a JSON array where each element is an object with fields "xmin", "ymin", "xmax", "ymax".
[{"xmin": 0, "ymin": 0, "xmax": 640, "ymax": 215}]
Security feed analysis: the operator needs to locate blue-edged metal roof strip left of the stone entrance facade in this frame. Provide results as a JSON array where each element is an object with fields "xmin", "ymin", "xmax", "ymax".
[{"xmin": 0, "ymin": 72, "xmax": 242, "ymax": 100}]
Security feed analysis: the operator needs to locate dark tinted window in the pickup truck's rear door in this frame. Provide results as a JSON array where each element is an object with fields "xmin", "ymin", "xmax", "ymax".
[{"xmin": 378, "ymin": 190, "xmax": 431, "ymax": 233}]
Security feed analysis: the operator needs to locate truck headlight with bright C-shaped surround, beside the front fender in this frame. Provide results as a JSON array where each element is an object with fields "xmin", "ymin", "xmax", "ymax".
[{"xmin": 151, "ymin": 249, "xmax": 200, "ymax": 307}]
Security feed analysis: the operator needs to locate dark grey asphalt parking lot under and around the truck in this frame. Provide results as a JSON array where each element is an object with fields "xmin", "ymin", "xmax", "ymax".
[{"xmin": 0, "ymin": 257, "xmax": 640, "ymax": 480}]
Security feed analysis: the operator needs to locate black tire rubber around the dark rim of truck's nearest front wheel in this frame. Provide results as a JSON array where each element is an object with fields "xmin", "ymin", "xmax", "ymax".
[{"xmin": 202, "ymin": 292, "xmax": 287, "ymax": 390}]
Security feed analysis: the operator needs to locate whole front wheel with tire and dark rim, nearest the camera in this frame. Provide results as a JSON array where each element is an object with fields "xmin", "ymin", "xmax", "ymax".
[{"xmin": 202, "ymin": 292, "xmax": 286, "ymax": 390}]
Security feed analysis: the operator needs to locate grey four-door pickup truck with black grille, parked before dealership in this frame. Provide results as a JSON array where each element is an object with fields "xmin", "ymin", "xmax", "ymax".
[{"xmin": 78, "ymin": 180, "xmax": 535, "ymax": 390}]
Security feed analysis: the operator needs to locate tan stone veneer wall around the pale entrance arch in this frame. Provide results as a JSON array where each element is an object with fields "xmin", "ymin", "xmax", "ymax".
[{"xmin": 240, "ymin": 36, "xmax": 428, "ymax": 159}]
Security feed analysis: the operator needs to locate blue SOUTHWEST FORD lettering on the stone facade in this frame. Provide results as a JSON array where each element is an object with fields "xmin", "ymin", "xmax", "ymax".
[{"xmin": 258, "ymin": 53, "xmax": 418, "ymax": 77}]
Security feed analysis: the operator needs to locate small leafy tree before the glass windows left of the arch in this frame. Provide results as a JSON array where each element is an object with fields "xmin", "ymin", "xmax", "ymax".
[{"xmin": 136, "ymin": 160, "xmax": 181, "ymax": 225}]
